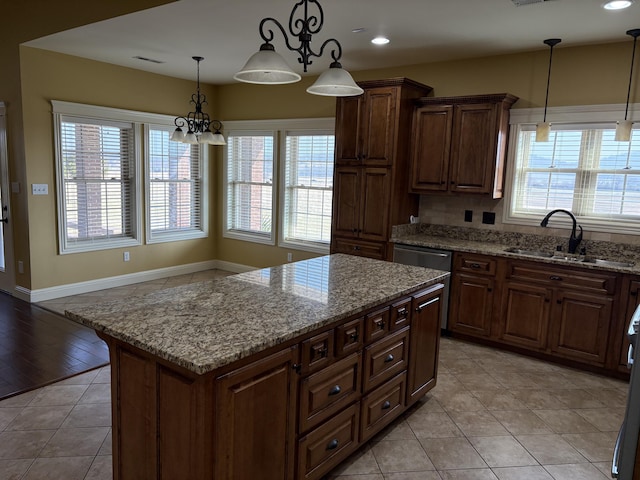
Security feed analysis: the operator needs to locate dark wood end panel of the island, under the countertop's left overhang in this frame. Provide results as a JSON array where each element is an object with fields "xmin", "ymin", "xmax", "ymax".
[{"xmin": 98, "ymin": 333, "xmax": 213, "ymax": 480}]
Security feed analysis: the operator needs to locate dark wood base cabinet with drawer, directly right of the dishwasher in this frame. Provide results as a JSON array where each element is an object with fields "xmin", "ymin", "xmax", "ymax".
[{"xmin": 448, "ymin": 253, "xmax": 497, "ymax": 337}]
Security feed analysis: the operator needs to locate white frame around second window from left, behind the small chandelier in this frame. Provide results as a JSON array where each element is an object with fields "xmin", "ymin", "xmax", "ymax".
[{"xmin": 144, "ymin": 123, "xmax": 209, "ymax": 244}]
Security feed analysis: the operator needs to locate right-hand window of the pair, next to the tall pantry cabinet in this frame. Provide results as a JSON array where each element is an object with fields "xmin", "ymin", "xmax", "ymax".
[{"xmin": 281, "ymin": 132, "xmax": 334, "ymax": 249}]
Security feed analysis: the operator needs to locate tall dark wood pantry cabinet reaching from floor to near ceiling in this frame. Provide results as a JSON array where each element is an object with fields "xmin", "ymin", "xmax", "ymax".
[{"xmin": 331, "ymin": 78, "xmax": 432, "ymax": 260}]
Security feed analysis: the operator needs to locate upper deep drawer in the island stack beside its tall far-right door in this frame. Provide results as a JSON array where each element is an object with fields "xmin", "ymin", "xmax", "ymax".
[{"xmin": 363, "ymin": 328, "xmax": 409, "ymax": 392}]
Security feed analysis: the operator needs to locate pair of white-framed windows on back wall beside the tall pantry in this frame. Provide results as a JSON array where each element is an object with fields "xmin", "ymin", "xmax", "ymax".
[{"xmin": 223, "ymin": 119, "xmax": 334, "ymax": 253}]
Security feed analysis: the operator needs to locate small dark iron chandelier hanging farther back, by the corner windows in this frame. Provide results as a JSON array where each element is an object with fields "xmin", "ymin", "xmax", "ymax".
[{"xmin": 170, "ymin": 57, "xmax": 227, "ymax": 145}]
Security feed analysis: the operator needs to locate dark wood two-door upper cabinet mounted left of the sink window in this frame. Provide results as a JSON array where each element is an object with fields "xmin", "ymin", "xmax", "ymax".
[{"xmin": 410, "ymin": 93, "xmax": 518, "ymax": 198}]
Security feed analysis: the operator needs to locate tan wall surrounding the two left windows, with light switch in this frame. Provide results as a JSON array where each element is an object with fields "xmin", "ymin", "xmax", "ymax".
[{"xmin": 17, "ymin": 47, "xmax": 216, "ymax": 289}]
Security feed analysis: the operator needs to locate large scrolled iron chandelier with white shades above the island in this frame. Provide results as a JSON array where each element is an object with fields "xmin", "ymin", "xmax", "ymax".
[{"xmin": 233, "ymin": 0, "xmax": 364, "ymax": 97}]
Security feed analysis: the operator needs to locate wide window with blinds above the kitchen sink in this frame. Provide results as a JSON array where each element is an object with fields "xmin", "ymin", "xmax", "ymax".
[{"xmin": 505, "ymin": 105, "xmax": 640, "ymax": 233}]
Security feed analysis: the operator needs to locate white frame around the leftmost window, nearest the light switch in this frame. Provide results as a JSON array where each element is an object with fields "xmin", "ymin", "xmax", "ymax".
[{"xmin": 51, "ymin": 100, "xmax": 142, "ymax": 254}]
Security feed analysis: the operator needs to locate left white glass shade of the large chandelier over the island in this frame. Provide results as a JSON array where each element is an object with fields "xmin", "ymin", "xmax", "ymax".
[{"xmin": 233, "ymin": 43, "xmax": 302, "ymax": 85}]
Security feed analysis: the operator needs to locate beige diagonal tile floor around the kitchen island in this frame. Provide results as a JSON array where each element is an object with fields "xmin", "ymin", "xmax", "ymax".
[{"xmin": 0, "ymin": 271, "xmax": 627, "ymax": 480}]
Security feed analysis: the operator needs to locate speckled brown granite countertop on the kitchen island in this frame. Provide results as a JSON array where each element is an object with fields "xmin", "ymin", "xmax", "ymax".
[{"xmin": 65, "ymin": 254, "xmax": 449, "ymax": 374}]
